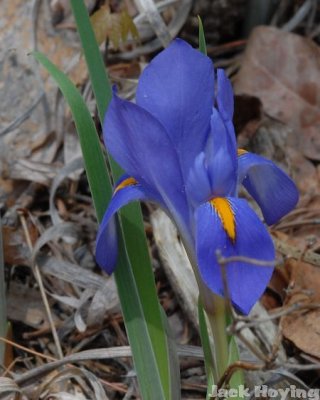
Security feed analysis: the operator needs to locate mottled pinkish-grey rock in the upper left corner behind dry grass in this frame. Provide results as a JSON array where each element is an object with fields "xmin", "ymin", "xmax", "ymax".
[{"xmin": 0, "ymin": 0, "xmax": 87, "ymax": 205}]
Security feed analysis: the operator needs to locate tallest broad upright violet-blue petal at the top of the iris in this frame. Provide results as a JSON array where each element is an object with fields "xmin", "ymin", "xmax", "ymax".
[{"xmin": 136, "ymin": 39, "xmax": 214, "ymax": 174}]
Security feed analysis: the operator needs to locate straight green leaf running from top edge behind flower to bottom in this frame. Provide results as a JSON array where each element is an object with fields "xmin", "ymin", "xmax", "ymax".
[{"xmin": 71, "ymin": 0, "xmax": 176, "ymax": 399}]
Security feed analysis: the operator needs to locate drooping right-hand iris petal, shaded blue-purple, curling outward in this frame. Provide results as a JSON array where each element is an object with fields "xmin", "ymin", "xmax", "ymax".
[{"xmin": 238, "ymin": 151, "xmax": 299, "ymax": 225}]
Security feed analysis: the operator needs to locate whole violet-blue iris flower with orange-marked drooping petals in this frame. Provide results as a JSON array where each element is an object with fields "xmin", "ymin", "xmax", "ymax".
[{"xmin": 96, "ymin": 39, "xmax": 298, "ymax": 314}]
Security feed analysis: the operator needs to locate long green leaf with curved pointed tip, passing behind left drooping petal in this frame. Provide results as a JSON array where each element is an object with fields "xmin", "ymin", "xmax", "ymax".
[{"xmin": 34, "ymin": 52, "xmax": 170, "ymax": 400}]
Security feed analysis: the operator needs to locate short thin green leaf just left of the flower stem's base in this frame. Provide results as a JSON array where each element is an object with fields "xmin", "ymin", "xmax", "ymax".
[{"xmin": 198, "ymin": 298, "xmax": 215, "ymax": 400}]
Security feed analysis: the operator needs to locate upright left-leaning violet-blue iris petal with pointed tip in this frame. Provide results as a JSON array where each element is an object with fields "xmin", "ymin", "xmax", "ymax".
[{"xmin": 103, "ymin": 94, "xmax": 189, "ymax": 227}]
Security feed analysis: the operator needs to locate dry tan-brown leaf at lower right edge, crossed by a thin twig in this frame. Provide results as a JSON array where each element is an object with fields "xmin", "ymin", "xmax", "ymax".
[{"xmin": 281, "ymin": 259, "xmax": 320, "ymax": 358}]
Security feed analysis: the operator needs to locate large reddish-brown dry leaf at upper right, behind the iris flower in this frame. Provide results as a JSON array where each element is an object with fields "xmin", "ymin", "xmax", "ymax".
[{"xmin": 234, "ymin": 27, "xmax": 320, "ymax": 160}]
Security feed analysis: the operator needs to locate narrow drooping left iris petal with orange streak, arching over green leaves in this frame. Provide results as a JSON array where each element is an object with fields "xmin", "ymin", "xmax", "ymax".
[{"xmin": 95, "ymin": 175, "xmax": 161, "ymax": 274}]
